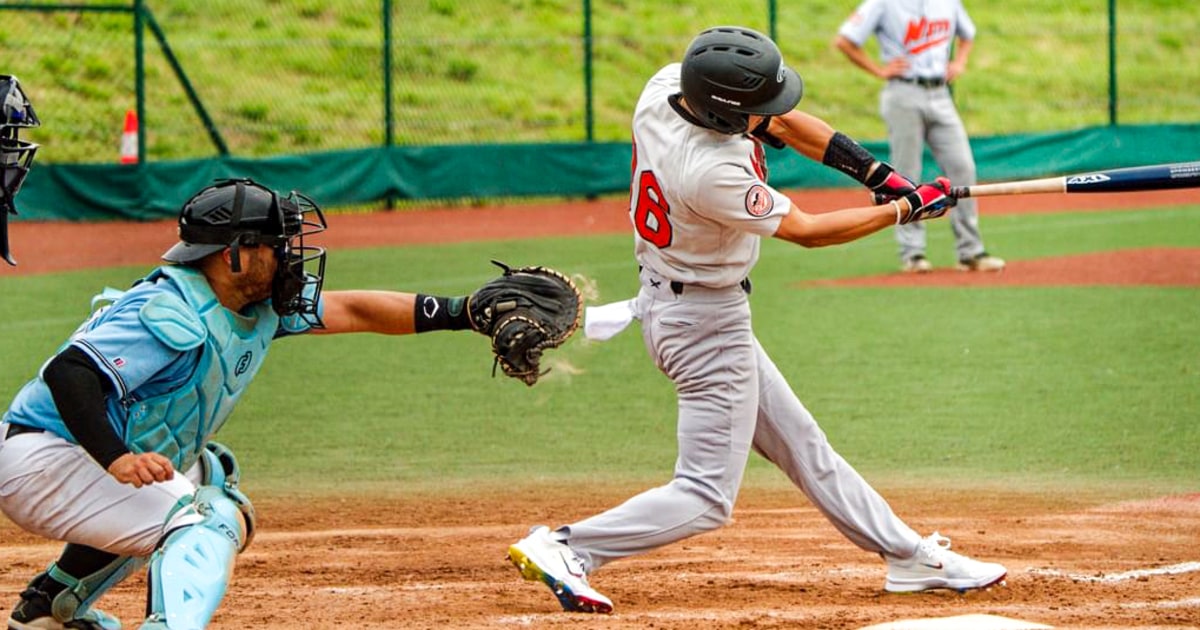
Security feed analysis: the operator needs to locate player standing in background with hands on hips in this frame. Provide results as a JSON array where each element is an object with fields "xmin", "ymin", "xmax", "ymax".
[{"xmin": 834, "ymin": 0, "xmax": 1004, "ymax": 274}]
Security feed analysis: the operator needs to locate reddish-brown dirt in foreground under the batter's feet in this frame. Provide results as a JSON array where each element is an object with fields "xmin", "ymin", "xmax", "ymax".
[{"xmin": 0, "ymin": 487, "xmax": 1200, "ymax": 630}]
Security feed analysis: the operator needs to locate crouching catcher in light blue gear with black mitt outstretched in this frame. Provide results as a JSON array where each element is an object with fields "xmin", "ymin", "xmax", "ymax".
[{"xmin": 0, "ymin": 179, "xmax": 581, "ymax": 630}]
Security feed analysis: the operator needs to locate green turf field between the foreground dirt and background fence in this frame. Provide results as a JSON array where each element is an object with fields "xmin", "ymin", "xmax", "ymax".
[{"xmin": 0, "ymin": 206, "xmax": 1200, "ymax": 494}]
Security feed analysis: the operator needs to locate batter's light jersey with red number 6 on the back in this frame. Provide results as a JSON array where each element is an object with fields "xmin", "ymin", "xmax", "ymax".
[{"xmin": 629, "ymin": 64, "xmax": 792, "ymax": 288}]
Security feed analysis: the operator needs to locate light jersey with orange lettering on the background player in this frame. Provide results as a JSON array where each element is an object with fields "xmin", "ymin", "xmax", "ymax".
[{"xmin": 838, "ymin": 0, "xmax": 976, "ymax": 78}]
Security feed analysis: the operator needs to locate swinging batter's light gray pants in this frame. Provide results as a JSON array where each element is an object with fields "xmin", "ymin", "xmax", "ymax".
[{"xmin": 560, "ymin": 271, "xmax": 920, "ymax": 571}]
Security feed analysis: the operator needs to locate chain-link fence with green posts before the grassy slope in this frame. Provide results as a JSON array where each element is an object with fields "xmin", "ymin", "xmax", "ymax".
[{"xmin": 0, "ymin": 0, "xmax": 1200, "ymax": 162}]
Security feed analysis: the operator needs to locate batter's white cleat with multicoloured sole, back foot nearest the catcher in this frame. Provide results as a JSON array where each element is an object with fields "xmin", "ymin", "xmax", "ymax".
[{"xmin": 509, "ymin": 526, "xmax": 612, "ymax": 613}]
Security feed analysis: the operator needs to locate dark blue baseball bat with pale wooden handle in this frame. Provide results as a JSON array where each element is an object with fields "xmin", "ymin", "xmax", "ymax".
[{"xmin": 950, "ymin": 162, "xmax": 1200, "ymax": 199}]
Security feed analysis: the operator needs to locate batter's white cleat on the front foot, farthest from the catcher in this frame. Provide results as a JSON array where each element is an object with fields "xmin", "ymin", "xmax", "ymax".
[{"xmin": 883, "ymin": 532, "xmax": 1008, "ymax": 593}]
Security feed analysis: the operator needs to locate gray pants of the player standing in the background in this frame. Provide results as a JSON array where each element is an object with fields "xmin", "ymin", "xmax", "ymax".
[{"xmin": 880, "ymin": 80, "xmax": 984, "ymax": 260}]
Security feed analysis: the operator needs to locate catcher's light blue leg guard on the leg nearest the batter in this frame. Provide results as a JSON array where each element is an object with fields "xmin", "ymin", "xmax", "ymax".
[{"xmin": 149, "ymin": 486, "xmax": 245, "ymax": 629}]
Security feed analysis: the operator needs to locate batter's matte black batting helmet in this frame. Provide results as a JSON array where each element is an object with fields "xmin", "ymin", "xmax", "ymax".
[{"xmin": 680, "ymin": 26, "xmax": 804, "ymax": 134}]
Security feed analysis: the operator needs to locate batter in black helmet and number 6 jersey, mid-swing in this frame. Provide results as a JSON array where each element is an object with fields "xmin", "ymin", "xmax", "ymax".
[{"xmin": 509, "ymin": 26, "xmax": 1006, "ymax": 612}]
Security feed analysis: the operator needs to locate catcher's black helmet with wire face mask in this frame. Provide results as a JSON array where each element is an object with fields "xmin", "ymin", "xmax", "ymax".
[{"xmin": 162, "ymin": 179, "xmax": 325, "ymax": 328}]
